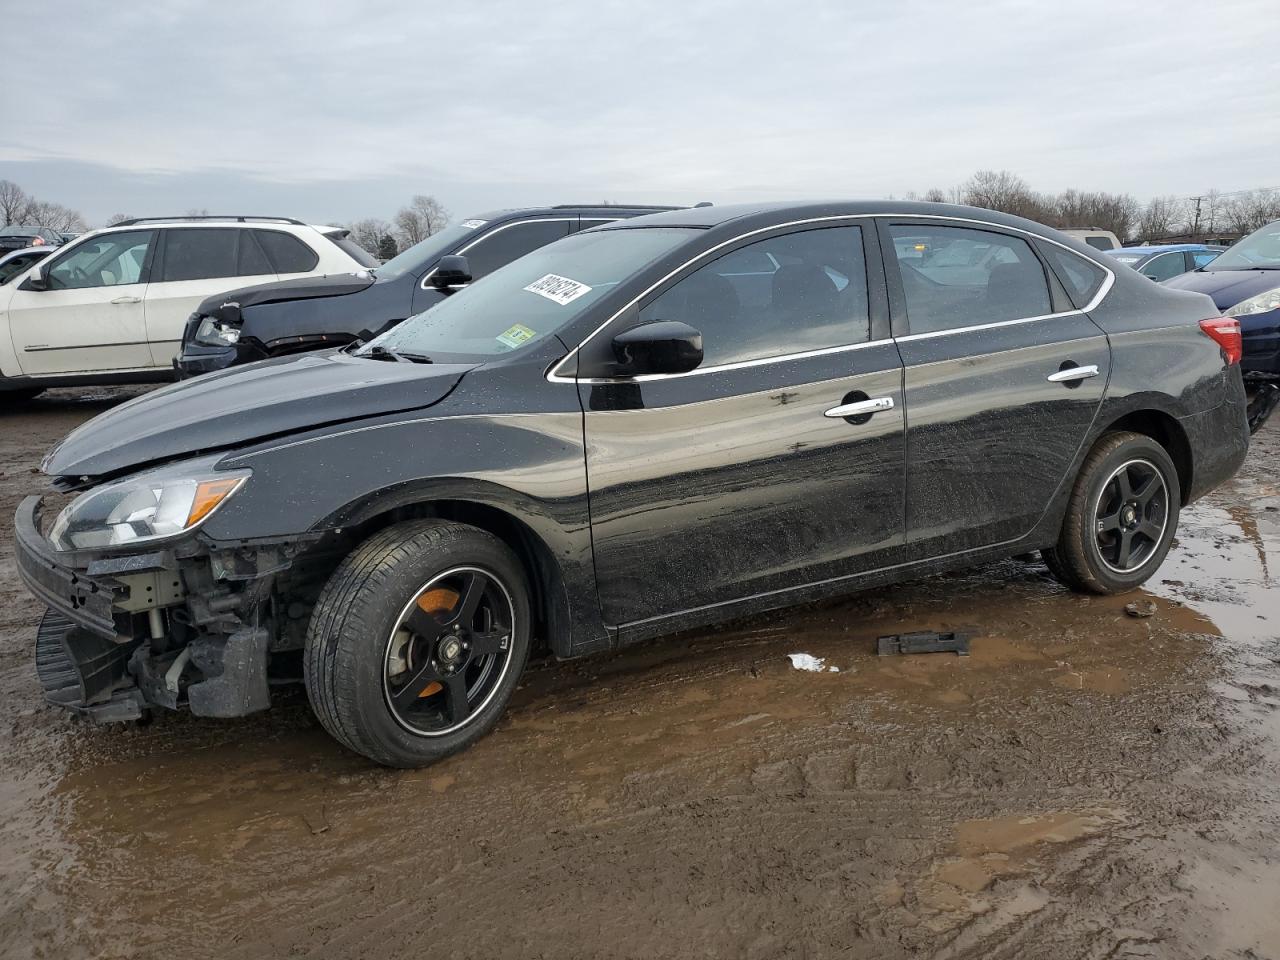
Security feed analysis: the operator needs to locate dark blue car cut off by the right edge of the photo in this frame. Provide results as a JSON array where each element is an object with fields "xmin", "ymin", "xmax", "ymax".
[{"xmin": 1165, "ymin": 220, "xmax": 1280, "ymax": 431}]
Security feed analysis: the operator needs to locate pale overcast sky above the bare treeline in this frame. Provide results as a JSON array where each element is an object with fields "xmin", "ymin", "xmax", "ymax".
[{"xmin": 0, "ymin": 0, "xmax": 1280, "ymax": 224}]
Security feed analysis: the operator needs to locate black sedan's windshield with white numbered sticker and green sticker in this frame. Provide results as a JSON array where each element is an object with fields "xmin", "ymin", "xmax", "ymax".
[{"xmin": 358, "ymin": 228, "xmax": 694, "ymax": 360}]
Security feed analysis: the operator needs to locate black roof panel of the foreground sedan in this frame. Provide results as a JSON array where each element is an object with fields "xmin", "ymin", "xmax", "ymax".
[{"xmin": 596, "ymin": 200, "xmax": 1097, "ymax": 239}]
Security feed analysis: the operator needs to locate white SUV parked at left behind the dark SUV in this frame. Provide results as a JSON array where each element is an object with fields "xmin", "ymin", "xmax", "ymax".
[{"xmin": 0, "ymin": 216, "xmax": 378, "ymax": 406}]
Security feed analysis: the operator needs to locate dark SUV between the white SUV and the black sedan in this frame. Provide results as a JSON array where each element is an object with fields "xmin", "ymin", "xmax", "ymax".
[{"xmin": 174, "ymin": 205, "xmax": 677, "ymax": 379}]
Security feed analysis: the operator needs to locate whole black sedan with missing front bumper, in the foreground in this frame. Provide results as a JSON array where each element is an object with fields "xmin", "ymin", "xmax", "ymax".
[{"xmin": 17, "ymin": 202, "xmax": 1248, "ymax": 767}]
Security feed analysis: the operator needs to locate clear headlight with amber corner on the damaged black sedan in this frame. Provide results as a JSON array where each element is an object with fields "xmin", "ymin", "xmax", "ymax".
[{"xmin": 49, "ymin": 470, "xmax": 250, "ymax": 550}]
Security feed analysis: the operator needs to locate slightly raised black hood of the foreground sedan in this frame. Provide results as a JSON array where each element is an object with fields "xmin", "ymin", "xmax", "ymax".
[{"xmin": 42, "ymin": 352, "xmax": 475, "ymax": 477}]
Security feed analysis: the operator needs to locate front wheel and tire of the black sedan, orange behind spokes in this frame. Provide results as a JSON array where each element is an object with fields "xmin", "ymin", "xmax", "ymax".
[{"xmin": 303, "ymin": 520, "xmax": 531, "ymax": 768}]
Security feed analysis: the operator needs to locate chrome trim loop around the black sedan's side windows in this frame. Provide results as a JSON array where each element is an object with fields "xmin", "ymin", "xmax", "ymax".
[{"xmin": 545, "ymin": 212, "xmax": 1116, "ymax": 384}]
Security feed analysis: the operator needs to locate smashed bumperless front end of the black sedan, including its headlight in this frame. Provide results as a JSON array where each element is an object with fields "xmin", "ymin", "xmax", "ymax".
[{"xmin": 15, "ymin": 472, "xmax": 317, "ymax": 722}]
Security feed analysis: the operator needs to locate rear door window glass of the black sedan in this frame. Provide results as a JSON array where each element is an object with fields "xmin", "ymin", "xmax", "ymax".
[{"xmin": 890, "ymin": 224, "xmax": 1053, "ymax": 334}]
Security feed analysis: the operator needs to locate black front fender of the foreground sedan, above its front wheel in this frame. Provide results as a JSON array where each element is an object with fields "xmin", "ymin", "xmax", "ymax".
[{"xmin": 204, "ymin": 411, "xmax": 608, "ymax": 653}]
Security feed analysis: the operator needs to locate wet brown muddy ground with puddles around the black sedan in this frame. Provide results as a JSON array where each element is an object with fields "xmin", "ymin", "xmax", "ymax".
[{"xmin": 0, "ymin": 390, "xmax": 1280, "ymax": 960}]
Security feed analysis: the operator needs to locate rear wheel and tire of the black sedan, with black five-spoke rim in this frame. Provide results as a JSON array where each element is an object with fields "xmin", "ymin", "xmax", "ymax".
[{"xmin": 1043, "ymin": 431, "xmax": 1181, "ymax": 594}]
